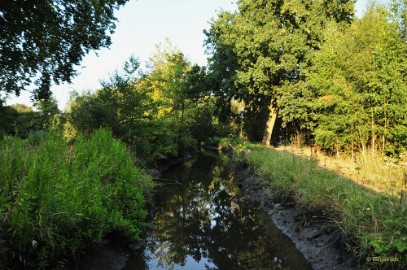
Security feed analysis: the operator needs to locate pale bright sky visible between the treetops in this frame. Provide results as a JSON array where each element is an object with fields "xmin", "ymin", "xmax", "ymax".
[{"xmin": 7, "ymin": 0, "xmax": 380, "ymax": 109}]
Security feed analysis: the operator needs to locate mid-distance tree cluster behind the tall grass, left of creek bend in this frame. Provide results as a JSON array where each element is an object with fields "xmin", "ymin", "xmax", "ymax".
[{"xmin": 65, "ymin": 47, "xmax": 222, "ymax": 163}]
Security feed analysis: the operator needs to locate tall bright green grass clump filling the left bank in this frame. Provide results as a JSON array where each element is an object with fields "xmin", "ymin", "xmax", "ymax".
[{"xmin": 0, "ymin": 130, "xmax": 152, "ymax": 269}]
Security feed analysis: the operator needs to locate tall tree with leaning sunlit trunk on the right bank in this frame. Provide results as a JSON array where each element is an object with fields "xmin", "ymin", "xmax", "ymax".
[{"xmin": 208, "ymin": 0, "xmax": 353, "ymax": 145}]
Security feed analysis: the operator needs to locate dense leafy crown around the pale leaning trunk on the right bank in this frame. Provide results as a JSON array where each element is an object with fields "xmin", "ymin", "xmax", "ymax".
[{"xmin": 206, "ymin": 0, "xmax": 354, "ymax": 144}]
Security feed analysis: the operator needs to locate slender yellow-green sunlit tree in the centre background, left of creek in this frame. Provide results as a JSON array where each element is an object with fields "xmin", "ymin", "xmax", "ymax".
[{"xmin": 138, "ymin": 40, "xmax": 202, "ymax": 155}]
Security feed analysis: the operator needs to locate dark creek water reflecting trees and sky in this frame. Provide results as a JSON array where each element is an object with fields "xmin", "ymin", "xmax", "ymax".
[{"xmin": 124, "ymin": 151, "xmax": 311, "ymax": 270}]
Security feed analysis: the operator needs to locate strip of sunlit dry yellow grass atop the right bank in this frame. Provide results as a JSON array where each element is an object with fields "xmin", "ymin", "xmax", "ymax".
[{"xmin": 276, "ymin": 146, "xmax": 407, "ymax": 197}]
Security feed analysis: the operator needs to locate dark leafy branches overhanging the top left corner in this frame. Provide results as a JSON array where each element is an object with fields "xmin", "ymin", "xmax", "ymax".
[{"xmin": 0, "ymin": 0, "xmax": 128, "ymax": 99}]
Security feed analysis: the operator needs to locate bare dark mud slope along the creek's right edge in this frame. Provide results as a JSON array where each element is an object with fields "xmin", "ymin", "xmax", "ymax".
[{"xmin": 234, "ymin": 163, "xmax": 357, "ymax": 270}]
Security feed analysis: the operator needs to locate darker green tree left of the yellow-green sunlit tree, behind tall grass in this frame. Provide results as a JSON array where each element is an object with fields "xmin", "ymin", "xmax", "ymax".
[{"xmin": 68, "ymin": 56, "xmax": 148, "ymax": 144}]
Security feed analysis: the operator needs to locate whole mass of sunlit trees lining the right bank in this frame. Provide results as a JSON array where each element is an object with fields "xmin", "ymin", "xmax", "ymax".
[{"xmin": 205, "ymin": 0, "xmax": 407, "ymax": 156}]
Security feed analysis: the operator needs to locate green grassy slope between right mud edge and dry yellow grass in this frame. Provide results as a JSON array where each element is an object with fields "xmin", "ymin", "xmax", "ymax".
[{"xmin": 241, "ymin": 145, "xmax": 407, "ymax": 269}]
